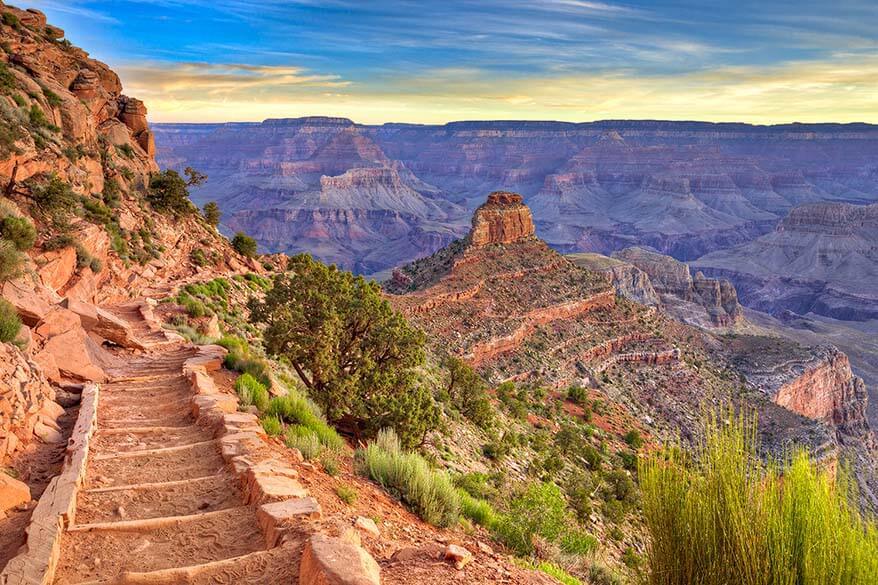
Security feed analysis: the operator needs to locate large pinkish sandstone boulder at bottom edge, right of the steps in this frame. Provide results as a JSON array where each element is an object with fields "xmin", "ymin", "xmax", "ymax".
[{"xmin": 299, "ymin": 533, "xmax": 381, "ymax": 585}]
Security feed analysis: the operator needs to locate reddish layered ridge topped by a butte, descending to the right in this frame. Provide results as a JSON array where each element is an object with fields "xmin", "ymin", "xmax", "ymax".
[{"xmin": 385, "ymin": 193, "xmax": 876, "ymax": 508}]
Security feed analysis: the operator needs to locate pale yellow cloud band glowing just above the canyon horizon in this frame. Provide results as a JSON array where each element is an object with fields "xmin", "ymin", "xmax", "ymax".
[{"xmin": 126, "ymin": 57, "xmax": 878, "ymax": 124}]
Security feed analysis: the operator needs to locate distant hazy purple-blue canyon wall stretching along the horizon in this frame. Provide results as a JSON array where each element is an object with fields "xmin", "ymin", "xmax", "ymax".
[{"xmin": 156, "ymin": 118, "xmax": 878, "ymax": 272}]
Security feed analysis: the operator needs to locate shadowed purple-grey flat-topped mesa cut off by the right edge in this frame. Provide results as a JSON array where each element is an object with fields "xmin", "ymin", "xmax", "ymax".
[{"xmin": 692, "ymin": 203, "xmax": 878, "ymax": 321}]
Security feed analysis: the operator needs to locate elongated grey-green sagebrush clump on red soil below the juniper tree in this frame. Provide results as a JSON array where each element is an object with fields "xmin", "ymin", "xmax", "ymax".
[{"xmin": 357, "ymin": 429, "xmax": 460, "ymax": 527}]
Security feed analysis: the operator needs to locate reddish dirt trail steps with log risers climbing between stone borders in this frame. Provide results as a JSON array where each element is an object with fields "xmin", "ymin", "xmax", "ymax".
[{"xmin": 55, "ymin": 346, "xmax": 298, "ymax": 585}]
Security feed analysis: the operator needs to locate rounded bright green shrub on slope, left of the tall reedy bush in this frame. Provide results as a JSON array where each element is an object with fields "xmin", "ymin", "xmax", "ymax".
[{"xmin": 494, "ymin": 482, "xmax": 567, "ymax": 556}]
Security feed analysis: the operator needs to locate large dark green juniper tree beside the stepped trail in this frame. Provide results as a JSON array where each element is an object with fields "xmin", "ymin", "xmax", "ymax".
[{"xmin": 251, "ymin": 255, "xmax": 438, "ymax": 446}]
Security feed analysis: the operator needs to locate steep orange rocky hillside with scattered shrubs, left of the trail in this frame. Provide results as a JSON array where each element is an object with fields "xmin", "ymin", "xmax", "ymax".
[{"xmin": 0, "ymin": 2, "xmax": 262, "ymax": 486}]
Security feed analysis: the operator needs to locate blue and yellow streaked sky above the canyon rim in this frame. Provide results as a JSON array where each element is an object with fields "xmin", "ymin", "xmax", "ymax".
[{"xmin": 24, "ymin": 0, "xmax": 878, "ymax": 124}]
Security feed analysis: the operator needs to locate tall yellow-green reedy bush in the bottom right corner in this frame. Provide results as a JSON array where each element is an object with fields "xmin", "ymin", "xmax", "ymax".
[{"xmin": 639, "ymin": 414, "xmax": 878, "ymax": 585}]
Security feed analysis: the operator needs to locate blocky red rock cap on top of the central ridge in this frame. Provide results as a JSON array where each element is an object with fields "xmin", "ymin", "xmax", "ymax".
[{"xmin": 470, "ymin": 191, "xmax": 534, "ymax": 246}]
